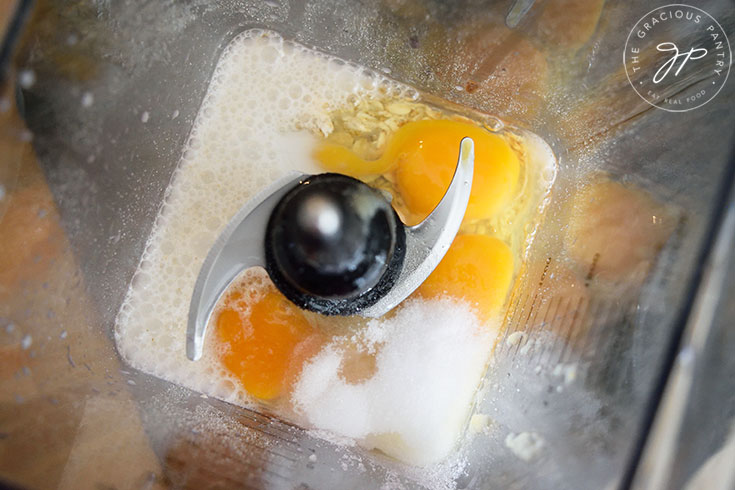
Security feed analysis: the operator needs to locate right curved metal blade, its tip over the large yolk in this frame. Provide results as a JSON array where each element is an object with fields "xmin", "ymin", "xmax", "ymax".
[{"xmin": 360, "ymin": 138, "xmax": 475, "ymax": 318}]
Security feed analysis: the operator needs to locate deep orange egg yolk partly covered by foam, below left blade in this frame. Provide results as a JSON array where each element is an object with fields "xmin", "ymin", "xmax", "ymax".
[{"xmin": 217, "ymin": 289, "xmax": 318, "ymax": 400}]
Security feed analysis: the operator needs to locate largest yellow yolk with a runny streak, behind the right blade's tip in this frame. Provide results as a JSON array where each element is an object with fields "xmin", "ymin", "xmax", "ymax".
[{"xmin": 316, "ymin": 120, "xmax": 520, "ymax": 220}]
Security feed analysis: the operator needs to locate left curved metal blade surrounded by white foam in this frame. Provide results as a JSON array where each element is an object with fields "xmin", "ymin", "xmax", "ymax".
[{"xmin": 186, "ymin": 173, "xmax": 308, "ymax": 361}]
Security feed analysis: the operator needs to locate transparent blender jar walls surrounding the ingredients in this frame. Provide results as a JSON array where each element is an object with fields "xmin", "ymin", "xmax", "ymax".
[{"xmin": 0, "ymin": 0, "xmax": 735, "ymax": 489}]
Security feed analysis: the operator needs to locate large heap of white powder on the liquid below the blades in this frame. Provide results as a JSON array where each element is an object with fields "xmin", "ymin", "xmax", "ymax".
[{"xmin": 292, "ymin": 301, "xmax": 497, "ymax": 465}]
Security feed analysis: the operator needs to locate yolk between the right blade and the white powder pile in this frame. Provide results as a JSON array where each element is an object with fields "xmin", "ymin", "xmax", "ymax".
[{"xmin": 418, "ymin": 235, "xmax": 513, "ymax": 320}]
